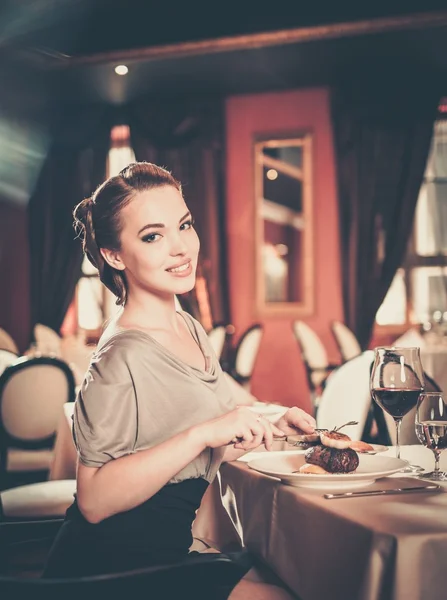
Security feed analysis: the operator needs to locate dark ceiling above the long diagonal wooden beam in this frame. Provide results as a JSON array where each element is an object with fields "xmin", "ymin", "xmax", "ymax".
[{"xmin": 0, "ymin": 0, "xmax": 447, "ymax": 56}]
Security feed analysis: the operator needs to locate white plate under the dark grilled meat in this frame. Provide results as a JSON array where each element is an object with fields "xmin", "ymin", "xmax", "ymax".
[{"xmin": 248, "ymin": 452, "xmax": 408, "ymax": 490}]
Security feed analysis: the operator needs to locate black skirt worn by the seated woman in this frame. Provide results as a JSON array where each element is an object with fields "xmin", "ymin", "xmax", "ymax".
[{"xmin": 43, "ymin": 478, "xmax": 212, "ymax": 578}]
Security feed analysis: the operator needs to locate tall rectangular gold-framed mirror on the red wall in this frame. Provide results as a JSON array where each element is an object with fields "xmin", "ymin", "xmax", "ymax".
[{"xmin": 254, "ymin": 133, "xmax": 314, "ymax": 316}]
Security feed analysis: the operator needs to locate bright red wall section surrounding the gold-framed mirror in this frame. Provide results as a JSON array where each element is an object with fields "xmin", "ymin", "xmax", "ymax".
[{"xmin": 226, "ymin": 88, "xmax": 343, "ymax": 410}]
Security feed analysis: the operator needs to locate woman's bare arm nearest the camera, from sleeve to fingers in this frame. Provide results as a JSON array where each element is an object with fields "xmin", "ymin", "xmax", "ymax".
[{"xmin": 77, "ymin": 407, "xmax": 278, "ymax": 523}]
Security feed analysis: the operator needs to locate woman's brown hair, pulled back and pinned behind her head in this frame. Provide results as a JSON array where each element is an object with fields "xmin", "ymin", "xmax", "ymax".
[{"xmin": 73, "ymin": 162, "xmax": 182, "ymax": 304}]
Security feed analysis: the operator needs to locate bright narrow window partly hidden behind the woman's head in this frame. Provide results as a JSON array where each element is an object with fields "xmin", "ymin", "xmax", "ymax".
[{"xmin": 76, "ymin": 125, "xmax": 135, "ymax": 336}]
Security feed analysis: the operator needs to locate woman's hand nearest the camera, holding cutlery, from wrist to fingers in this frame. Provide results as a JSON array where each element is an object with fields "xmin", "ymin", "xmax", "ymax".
[{"xmin": 198, "ymin": 406, "xmax": 284, "ymax": 450}]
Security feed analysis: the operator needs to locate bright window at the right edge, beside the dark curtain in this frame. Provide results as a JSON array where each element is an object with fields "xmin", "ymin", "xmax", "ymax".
[{"xmin": 376, "ymin": 112, "xmax": 447, "ymax": 325}]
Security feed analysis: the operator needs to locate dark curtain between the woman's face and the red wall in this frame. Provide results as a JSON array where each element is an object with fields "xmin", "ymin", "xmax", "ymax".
[{"xmin": 128, "ymin": 98, "xmax": 229, "ymax": 323}]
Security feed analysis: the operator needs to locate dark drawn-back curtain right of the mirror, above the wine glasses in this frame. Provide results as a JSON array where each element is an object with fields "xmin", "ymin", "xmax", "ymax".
[{"xmin": 331, "ymin": 70, "xmax": 440, "ymax": 349}]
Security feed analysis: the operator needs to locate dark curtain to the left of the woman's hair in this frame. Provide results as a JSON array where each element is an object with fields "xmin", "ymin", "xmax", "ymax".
[{"xmin": 28, "ymin": 107, "xmax": 110, "ymax": 331}]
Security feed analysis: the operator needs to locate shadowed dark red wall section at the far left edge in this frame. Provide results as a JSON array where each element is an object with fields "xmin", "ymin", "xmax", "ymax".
[{"xmin": 0, "ymin": 201, "xmax": 30, "ymax": 351}]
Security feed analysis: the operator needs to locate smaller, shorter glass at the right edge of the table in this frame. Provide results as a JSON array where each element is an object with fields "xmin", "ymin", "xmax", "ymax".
[{"xmin": 415, "ymin": 392, "xmax": 447, "ymax": 481}]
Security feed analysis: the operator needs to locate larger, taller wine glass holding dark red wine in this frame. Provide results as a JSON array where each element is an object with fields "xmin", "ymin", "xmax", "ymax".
[{"xmin": 371, "ymin": 347, "xmax": 424, "ymax": 473}]
